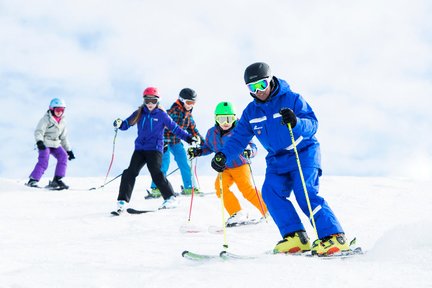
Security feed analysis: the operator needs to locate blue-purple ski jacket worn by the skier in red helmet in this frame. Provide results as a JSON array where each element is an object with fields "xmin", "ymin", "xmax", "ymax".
[{"xmin": 119, "ymin": 105, "xmax": 192, "ymax": 153}]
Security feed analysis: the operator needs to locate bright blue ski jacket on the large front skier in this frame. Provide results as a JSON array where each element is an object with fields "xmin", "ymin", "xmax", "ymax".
[{"xmin": 221, "ymin": 77, "xmax": 321, "ymax": 174}]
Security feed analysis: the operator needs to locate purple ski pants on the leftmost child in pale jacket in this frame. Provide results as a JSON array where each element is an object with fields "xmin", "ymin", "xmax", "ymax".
[{"xmin": 30, "ymin": 146, "xmax": 68, "ymax": 181}]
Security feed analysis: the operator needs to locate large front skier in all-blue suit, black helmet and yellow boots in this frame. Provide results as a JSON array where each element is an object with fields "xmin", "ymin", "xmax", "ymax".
[{"xmin": 211, "ymin": 62, "xmax": 349, "ymax": 255}]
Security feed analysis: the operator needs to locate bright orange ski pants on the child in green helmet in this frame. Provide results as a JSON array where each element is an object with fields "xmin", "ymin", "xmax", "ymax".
[{"xmin": 215, "ymin": 164, "xmax": 267, "ymax": 216}]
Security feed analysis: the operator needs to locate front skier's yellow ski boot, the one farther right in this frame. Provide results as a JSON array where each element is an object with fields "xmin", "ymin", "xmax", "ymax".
[{"xmin": 312, "ymin": 233, "xmax": 350, "ymax": 256}]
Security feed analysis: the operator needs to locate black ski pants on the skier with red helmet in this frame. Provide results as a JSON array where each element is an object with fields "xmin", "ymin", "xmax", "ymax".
[{"xmin": 117, "ymin": 150, "xmax": 174, "ymax": 202}]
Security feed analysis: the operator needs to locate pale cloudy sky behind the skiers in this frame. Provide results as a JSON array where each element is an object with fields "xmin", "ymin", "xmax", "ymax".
[{"xmin": 0, "ymin": 0, "xmax": 432, "ymax": 179}]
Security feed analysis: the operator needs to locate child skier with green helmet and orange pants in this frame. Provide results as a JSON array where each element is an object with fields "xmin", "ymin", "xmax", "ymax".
[{"xmin": 188, "ymin": 102, "xmax": 267, "ymax": 227}]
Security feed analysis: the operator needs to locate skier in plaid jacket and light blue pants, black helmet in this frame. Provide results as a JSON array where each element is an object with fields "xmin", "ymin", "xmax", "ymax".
[{"xmin": 151, "ymin": 88, "xmax": 203, "ymax": 198}]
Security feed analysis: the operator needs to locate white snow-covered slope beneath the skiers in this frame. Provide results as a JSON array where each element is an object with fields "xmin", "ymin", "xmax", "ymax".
[{"xmin": 0, "ymin": 175, "xmax": 432, "ymax": 288}]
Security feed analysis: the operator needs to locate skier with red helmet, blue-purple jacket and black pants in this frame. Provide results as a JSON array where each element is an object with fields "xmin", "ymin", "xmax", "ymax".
[{"xmin": 113, "ymin": 87, "xmax": 197, "ymax": 215}]
